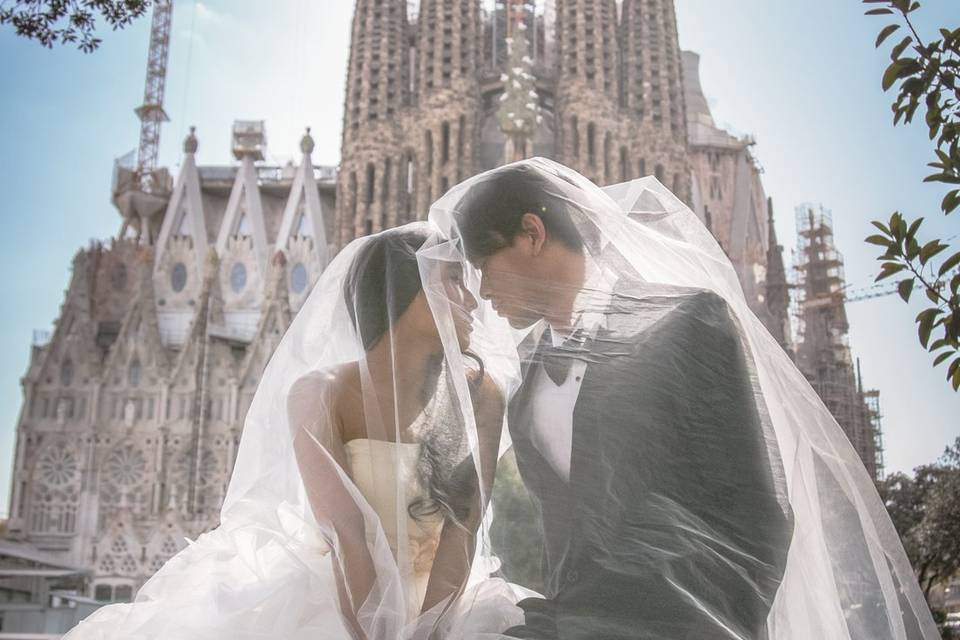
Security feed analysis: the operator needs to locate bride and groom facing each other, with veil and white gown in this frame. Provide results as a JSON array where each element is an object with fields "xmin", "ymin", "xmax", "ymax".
[{"xmin": 67, "ymin": 158, "xmax": 933, "ymax": 640}]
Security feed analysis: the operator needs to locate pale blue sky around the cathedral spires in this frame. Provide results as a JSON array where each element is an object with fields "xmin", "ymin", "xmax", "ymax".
[{"xmin": 0, "ymin": 0, "xmax": 960, "ymax": 513}]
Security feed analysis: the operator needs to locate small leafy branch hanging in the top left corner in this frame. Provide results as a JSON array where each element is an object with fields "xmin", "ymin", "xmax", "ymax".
[{"xmin": 0, "ymin": 0, "xmax": 150, "ymax": 53}]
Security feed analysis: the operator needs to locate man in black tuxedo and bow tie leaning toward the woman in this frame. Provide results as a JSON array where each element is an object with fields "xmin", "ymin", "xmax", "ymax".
[{"xmin": 455, "ymin": 164, "xmax": 792, "ymax": 640}]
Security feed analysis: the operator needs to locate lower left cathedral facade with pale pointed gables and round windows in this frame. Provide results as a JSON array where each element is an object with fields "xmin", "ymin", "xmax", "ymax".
[{"xmin": 4, "ymin": 127, "xmax": 335, "ymax": 601}]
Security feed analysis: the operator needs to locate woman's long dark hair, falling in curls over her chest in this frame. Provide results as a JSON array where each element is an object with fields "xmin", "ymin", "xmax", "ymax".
[{"xmin": 343, "ymin": 229, "xmax": 483, "ymax": 523}]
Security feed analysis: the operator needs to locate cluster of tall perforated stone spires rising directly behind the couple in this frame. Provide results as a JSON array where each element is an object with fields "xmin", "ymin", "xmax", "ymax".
[{"xmin": 336, "ymin": 0, "xmax": 691, "ymax": 248}]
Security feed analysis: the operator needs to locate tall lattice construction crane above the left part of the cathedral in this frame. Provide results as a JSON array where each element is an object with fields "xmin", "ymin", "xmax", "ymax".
[{"xmin": 113, "ymin": 0, "xmax": 173, "ymax": 245}]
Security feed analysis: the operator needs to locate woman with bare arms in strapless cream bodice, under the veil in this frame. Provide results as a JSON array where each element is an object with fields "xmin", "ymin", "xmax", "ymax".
[{"xmin": 287, "ymin": 225, "xmax": 520, "ymax": 636}]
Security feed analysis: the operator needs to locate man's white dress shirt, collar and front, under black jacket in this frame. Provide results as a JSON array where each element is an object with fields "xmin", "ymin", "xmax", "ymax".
[{"xmin": 529, "ymin": 256, "xmax": 614, "ymax": 482}]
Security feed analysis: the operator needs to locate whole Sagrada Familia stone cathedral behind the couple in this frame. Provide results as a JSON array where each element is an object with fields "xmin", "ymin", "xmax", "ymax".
[{"xmin": 5, "ymin": 0, "xmax": 879, "ymax": 602}]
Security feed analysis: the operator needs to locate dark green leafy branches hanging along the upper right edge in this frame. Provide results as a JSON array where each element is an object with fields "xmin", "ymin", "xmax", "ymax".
[{"xmin": 863, "ymin": 0, "xmax": 960, "ymax": 390}]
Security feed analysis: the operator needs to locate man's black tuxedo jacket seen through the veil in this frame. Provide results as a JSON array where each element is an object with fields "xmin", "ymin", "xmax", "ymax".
[{"xmin": 507, "ymin": 286, "xmax": 792, "ymax": 639}]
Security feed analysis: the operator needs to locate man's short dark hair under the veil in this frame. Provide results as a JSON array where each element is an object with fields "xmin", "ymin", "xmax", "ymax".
[{"xmin": 454, "ymin": 164, "xmax": 583, "ymax": 262}]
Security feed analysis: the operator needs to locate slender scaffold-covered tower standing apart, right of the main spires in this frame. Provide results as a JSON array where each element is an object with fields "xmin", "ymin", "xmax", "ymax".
[{"xmin": 794, "ymin": 204, "xmax": 882, "ymax": 479}]
